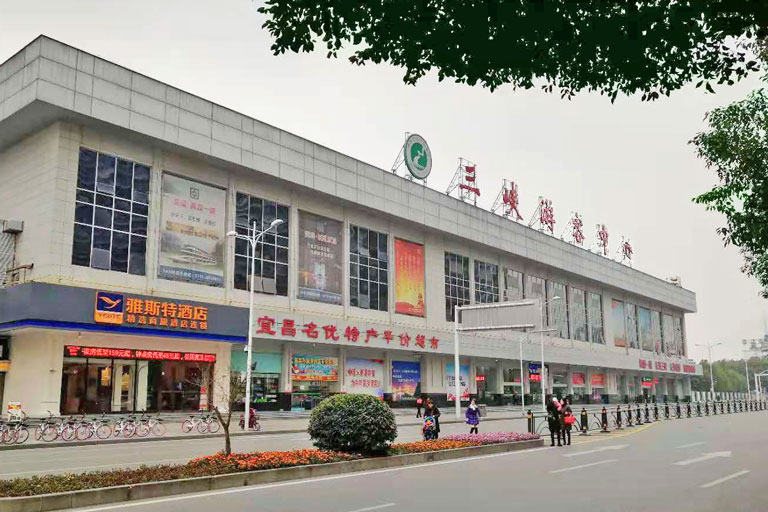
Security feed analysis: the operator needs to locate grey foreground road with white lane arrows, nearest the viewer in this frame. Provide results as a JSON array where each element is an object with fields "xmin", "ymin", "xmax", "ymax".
[{"xmin": 58, "ymin": 412, "xmax": 768, "ymax": 512}]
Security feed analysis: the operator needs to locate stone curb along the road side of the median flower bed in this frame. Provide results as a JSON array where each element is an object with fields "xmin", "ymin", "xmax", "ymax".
[{"xmin": 0, "ymin": 439, "xmax": 544, "ymax": 512}]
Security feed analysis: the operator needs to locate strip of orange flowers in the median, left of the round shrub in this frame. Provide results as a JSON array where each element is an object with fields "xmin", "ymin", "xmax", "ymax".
[{"xmin": 0, "ymin": 450, "xmax": 360, "ymax": 497}]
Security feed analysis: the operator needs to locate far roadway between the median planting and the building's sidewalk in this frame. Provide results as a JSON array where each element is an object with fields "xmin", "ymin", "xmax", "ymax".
[{"xmin": 0, "ymin": 413, "xmax": 536, "ymax": 479}]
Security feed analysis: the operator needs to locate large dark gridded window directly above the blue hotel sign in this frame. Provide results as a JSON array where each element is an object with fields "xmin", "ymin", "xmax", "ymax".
[{"xmin": 72, "ymin": 148, "xmax": 149, "ymax": 276}]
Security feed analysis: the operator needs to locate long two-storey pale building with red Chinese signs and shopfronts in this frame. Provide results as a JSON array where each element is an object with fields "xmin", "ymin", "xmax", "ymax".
[{"xmin": 0, "ymin": 36, "xmax": 701, "ymax": 416}]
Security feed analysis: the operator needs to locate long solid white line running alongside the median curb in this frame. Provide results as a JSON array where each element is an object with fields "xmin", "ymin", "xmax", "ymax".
[{"xmin": 73, "ymin": 447, "xmax": 549, "ymax": 512}]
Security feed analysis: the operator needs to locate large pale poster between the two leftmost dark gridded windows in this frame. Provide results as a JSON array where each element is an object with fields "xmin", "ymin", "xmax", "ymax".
[{"xmin": 157, "ymin": 174, "xmax": 227, "ymax": 286}]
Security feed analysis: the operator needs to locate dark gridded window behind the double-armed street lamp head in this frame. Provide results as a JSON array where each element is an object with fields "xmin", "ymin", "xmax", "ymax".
[{"xmin": 235, "ymin": 192, "xmax": 289, "ymax": 296}]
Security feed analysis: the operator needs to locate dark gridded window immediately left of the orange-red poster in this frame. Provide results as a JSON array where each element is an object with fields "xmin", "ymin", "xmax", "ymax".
[{"xmin": 349, "ymin": 226, "xmax": 389, "ymax": 311}]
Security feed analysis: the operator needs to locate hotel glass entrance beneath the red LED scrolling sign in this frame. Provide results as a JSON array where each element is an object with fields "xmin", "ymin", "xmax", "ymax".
[{"xmin": 61, "ymin": 346, "xmax": 216, "ymax": 414}]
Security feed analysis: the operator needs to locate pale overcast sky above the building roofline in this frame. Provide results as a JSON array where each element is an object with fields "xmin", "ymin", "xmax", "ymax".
[{"xmin": 0, "ymin": 0, "xmax": 768, "ymax": 360}]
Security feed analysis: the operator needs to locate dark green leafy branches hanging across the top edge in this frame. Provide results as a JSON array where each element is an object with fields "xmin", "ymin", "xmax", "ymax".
[{"xmin": 259, "ymin": 0, "xmax": 768, "ymax": 101}]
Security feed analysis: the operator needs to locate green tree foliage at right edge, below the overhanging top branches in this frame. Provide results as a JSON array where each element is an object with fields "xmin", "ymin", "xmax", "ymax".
[{"xmin": 691, "ymin": 89, "xmax": 768, "ymax": 298}]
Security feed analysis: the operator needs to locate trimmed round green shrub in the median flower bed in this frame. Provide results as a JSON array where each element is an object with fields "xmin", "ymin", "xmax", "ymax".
[{"xmin": 307, "ymin": 395, "xmax": 397, "ymax": 454}]
